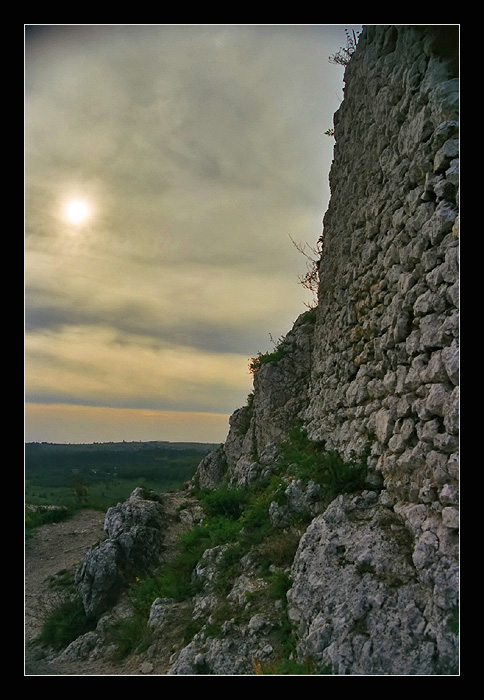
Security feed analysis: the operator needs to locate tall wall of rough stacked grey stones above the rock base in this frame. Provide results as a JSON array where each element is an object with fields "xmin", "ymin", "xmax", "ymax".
[{"xmin": 305, "ymin": 26, "xmax": 459, "ymax": 525}]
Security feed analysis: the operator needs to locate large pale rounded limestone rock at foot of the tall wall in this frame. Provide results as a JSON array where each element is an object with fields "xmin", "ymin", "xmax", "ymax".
[{"xmin": 288, "ymin": 492, "xmax": 458, "ymax": 675}]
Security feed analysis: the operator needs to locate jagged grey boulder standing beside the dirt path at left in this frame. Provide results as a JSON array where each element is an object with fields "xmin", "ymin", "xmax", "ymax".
[{"xmin": 75, "ymin": 488, "xmax": 164, "ymax": 617}]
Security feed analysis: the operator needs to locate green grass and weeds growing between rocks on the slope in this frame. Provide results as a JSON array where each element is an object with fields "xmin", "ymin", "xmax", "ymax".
[{"xmin": 106, "ymin": 426, "xmax": 367, "ymax": 674}]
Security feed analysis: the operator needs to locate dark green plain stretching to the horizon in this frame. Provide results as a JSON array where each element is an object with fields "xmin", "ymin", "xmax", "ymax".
[{"xmin": 25, "ymin": 442, "xmax": 215, "ymax": 510}]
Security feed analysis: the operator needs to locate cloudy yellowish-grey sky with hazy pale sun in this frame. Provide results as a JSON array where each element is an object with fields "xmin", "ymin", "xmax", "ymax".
[{"xmin": 24, "ymin": 25, "xmax": 361, "ymax": 443}]
